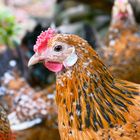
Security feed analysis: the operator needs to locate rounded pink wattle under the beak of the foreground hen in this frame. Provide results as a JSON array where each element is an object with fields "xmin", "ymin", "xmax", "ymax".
[{"xmin": 44, "ymin": 62, "xmax": 63, "ymax": 72}]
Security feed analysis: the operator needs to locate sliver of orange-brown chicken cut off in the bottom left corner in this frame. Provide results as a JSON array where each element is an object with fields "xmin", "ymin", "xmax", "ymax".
[{"xmin": 0, "ymin": 106, "xmax": 15, "ymax": 140}]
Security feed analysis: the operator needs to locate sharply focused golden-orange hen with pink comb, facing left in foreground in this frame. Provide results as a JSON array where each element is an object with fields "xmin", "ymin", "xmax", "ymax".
[{"xmin": 28, "ymin": 28, "xmax": 140, "ymax": 140}]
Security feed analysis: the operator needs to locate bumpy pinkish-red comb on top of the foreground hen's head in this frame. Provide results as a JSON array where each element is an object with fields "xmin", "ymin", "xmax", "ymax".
[{"xmin": 34, "ymin": 28, "xmax": 56, "ymax": 53}]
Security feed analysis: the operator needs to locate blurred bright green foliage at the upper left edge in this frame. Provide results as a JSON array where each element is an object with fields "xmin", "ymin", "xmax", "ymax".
[{"xmin": 0, "ymin": 8, "xmax": 19, "ymax": 47}]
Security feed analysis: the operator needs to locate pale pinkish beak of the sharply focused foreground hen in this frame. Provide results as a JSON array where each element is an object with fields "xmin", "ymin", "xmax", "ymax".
[{"xmin": 28, "ymin": 53, "xmax": 46, "ymax": 67}]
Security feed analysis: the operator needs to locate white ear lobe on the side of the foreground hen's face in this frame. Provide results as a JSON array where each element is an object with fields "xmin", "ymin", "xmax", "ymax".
[{"xmin": 63, "ymin": 48, "xmax": 78, "ymax": 67}]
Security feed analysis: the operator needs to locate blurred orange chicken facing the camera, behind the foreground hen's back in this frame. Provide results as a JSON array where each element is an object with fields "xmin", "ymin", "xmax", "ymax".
[{"xmin": 98, "ymin": 0, "xmax": 140, "ymax": 83}]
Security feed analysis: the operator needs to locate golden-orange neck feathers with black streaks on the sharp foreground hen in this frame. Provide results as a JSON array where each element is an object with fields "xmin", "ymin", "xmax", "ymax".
[{"xmin": 56, "ymin": 41, "xmax": 139, "ymax": 134}]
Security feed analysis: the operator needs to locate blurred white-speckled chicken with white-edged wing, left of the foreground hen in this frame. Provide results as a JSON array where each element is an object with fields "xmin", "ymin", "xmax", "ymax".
[{"xmin": 0, "ymin": 71, "xmax": 60, "ymax": 140}]
